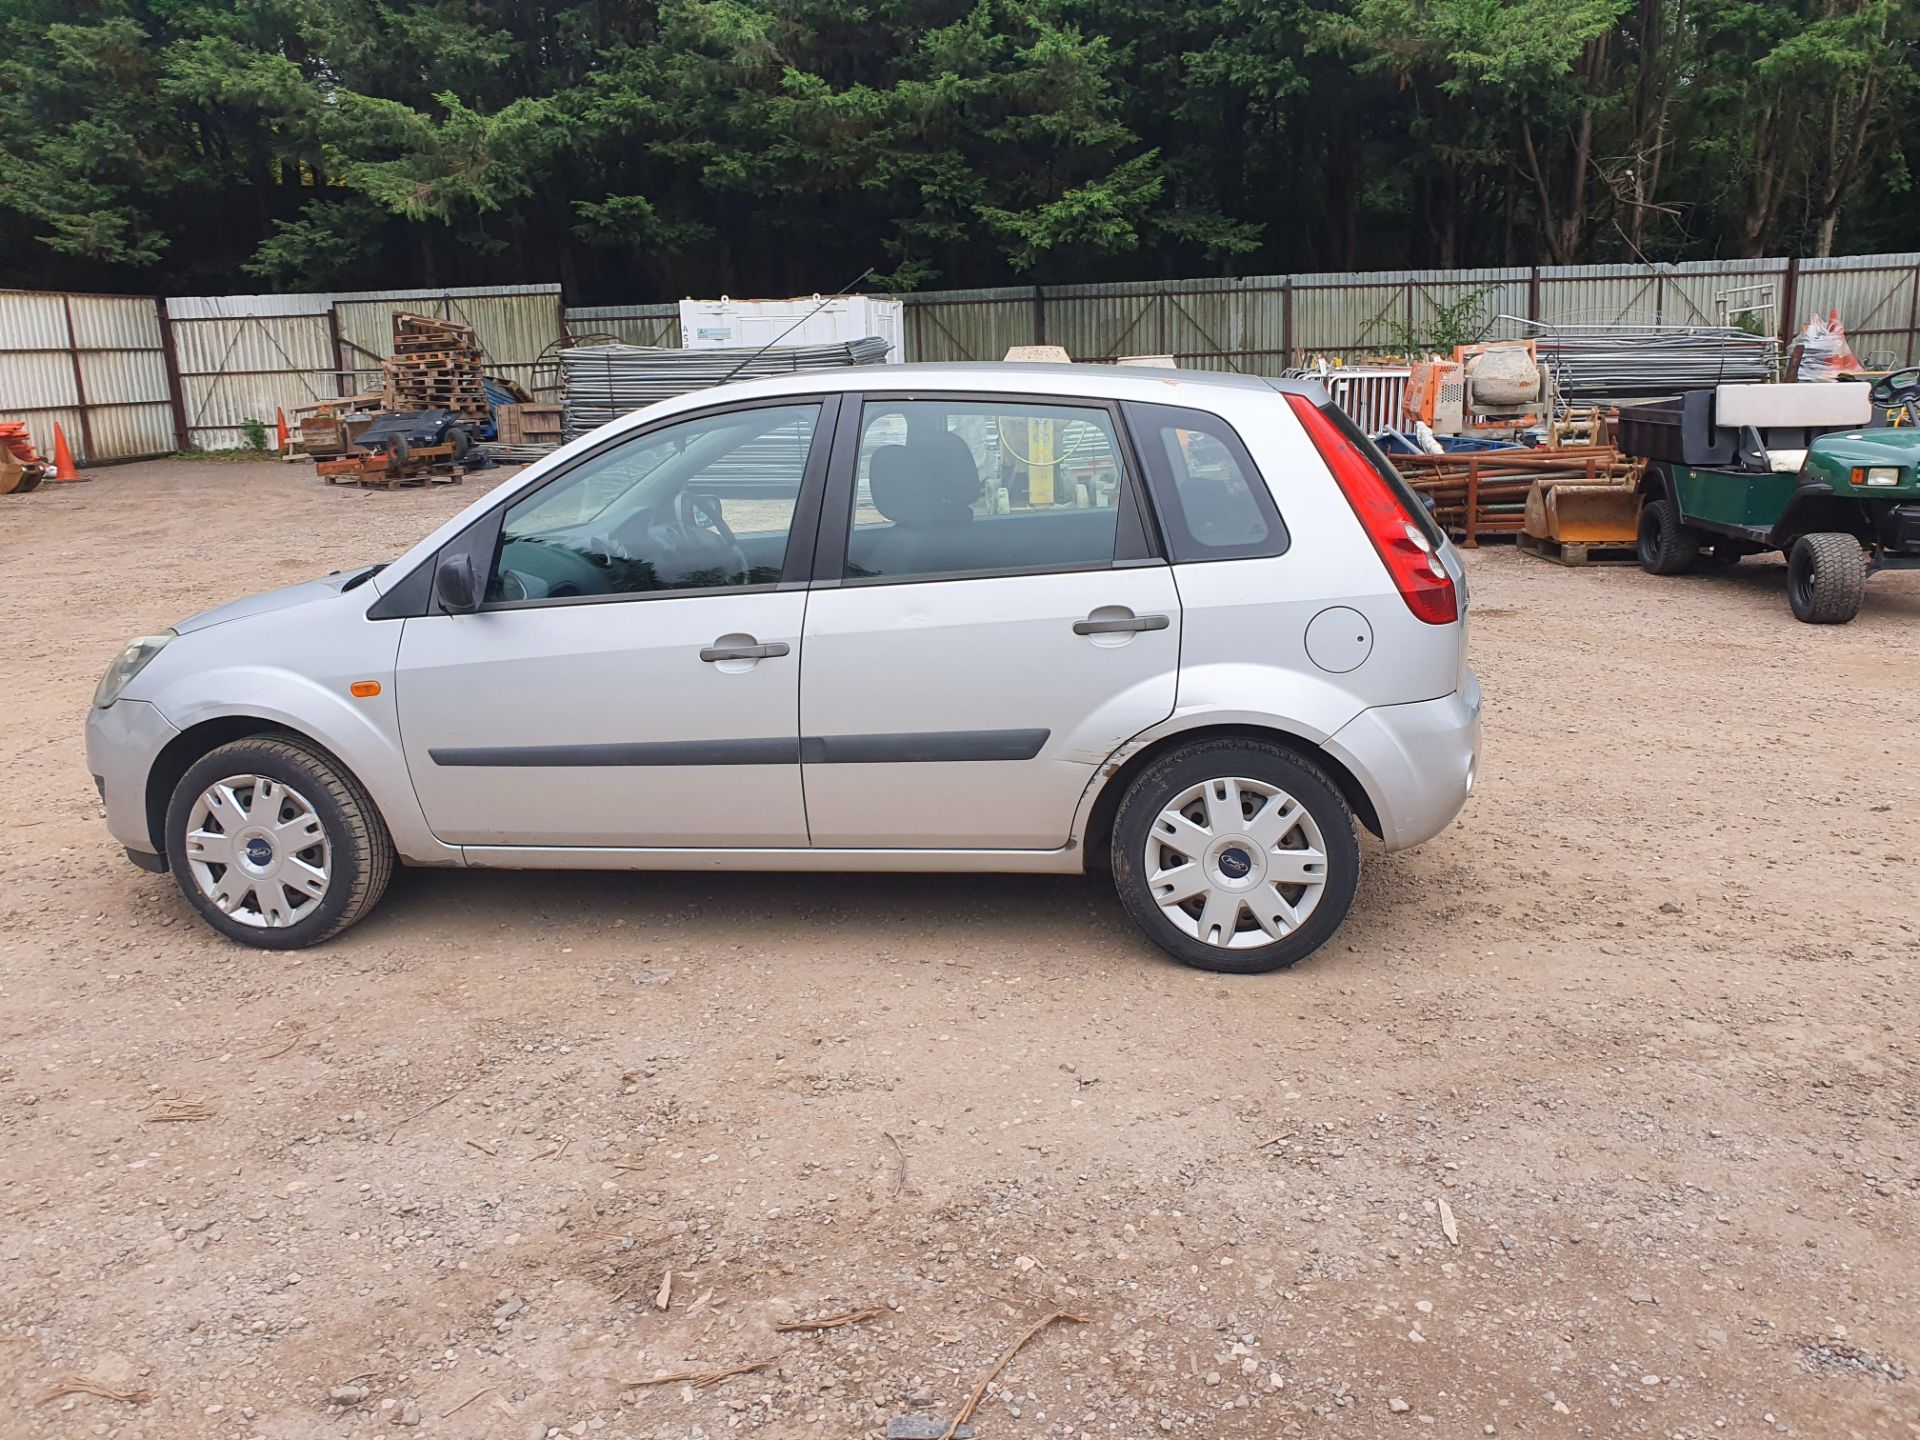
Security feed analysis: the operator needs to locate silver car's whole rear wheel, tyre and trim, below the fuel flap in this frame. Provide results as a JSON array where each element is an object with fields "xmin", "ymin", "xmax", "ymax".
[{"xmin": 1114, "ymin": 739, "xmax": 1359, "ymax": 975}]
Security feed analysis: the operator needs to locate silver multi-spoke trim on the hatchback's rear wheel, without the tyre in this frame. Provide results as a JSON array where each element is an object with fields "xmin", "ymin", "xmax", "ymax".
[{"xmin": 1144, "ymin": 776, "xmax": 1327, "ymax": 950}]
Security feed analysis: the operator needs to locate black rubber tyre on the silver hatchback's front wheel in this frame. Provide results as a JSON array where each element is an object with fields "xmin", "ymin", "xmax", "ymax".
[{"xmin": 165, "ymin": 735, "xmax": 394, "ymax": 950}]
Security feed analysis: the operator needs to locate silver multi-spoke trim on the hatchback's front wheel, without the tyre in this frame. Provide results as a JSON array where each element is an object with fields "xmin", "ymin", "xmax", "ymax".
[{"xmin": 186, "ymin": 776, "xmax": 334, "ymax": 929}]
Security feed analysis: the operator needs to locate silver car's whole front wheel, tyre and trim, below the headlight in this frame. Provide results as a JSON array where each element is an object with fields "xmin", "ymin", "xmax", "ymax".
[{"xmin": 165, "ymin": 735, "xmax": 394, "ymax": 950}]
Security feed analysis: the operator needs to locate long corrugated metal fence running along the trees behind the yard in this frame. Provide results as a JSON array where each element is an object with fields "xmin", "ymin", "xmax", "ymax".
[{"xmin": 0, "ymin": 253, "xmax": 1920, "ymax": 461}]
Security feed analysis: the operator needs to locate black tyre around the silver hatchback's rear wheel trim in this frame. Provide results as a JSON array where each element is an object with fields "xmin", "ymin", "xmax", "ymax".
[{"xmin": 1112, "ymin": 739, "xmax": 1359, "ymax": 975}]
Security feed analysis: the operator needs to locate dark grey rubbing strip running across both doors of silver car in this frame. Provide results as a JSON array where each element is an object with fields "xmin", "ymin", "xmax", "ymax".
[{"xmin": 428, "ymin": 730, "xmax": 1052, "ymax": 770}]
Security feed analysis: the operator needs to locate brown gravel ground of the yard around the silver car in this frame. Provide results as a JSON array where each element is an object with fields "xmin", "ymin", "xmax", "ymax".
[{"xmin": 0, "ymin": 463, "xmax": 1920, "ymax": 1440}]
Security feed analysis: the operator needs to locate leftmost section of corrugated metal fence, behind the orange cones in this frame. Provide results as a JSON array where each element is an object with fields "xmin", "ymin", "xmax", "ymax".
[{"xmin": 0, "ymin": 290, "xmax": 177, "ymax": 465}]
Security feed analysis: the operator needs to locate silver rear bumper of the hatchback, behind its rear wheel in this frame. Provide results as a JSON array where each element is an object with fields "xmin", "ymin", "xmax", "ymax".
[{"xmin": 1327, "ymin": 670, "xmax": 1480, "ymax": 851}]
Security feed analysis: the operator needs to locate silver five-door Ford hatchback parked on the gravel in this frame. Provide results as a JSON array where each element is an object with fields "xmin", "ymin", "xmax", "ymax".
[{"xmin": 86, "ymin": 365, "xmax": 1480, "ymax": 972}]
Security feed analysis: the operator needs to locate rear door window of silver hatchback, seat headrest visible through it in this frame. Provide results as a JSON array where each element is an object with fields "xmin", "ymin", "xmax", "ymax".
[{"xmin": 847, "ymin": 399, "xmax": 1131, "ymax": 580}]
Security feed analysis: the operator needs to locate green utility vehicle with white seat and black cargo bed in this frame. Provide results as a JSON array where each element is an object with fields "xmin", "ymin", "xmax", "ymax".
[{"xmin": 1620, "ymin": 384, "xmax": 1920, "ymax": 624}]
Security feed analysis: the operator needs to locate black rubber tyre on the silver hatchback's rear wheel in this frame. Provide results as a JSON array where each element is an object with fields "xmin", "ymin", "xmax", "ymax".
[{"xmin": 1112, "ymin": 739, "xmax": 1359, "ymax": 975}]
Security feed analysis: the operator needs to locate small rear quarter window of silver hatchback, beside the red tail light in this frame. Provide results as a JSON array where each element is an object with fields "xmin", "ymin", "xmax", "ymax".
[{"xmin": 1125, "ymin": 405, "xmax": 1286, "ymax": 563}]
